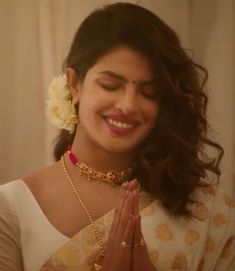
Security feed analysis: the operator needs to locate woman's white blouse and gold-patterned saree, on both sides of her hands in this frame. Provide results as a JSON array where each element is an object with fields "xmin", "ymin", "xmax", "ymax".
[{"xmin": 0, "ymin": 180, "xmax": 235, "ymax": 271}]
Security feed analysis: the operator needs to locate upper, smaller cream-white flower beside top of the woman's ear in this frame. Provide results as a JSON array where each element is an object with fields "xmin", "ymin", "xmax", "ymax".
[{"xmin": 48, "ymin": 75, "xmax": 71, "ymax": 100}]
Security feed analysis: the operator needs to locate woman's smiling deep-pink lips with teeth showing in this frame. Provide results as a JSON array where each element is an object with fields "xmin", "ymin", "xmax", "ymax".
[{"xmin": 104, "ymin": 115, "xmax": 139, "ymax": 136}]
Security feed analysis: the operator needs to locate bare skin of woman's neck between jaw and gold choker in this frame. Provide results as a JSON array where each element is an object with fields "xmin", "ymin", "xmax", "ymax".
[{"xmin": 72, "ymin": 129, "xmax": 135, "ymax": 172}]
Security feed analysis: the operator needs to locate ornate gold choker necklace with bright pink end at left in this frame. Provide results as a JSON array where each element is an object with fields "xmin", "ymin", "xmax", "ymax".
[{"xmin": 67, "ymin": 146, "xmax": 133, "ymax": 186}]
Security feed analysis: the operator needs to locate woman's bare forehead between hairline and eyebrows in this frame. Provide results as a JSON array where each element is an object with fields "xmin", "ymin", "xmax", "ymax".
[{"xmin": 87, "ymin": 47, "xmax": 153, "ymax": 80}]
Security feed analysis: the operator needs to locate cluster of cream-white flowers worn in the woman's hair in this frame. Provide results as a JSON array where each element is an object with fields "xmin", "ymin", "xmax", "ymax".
[{"xmin": 46, "ymin": 75, "xmax": 79, "ymax": 134}]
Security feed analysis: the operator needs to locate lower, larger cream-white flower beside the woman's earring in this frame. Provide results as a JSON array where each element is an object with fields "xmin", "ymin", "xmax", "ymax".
[{"xmin": 46, "ymin": 98, "xmax": 76, "ymax": 133}]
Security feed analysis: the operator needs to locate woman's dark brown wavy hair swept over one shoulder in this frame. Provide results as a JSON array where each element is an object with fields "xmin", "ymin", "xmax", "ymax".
[{"xmin": 54, "ymin": 3, "xmax": 223, "ymax": 217}]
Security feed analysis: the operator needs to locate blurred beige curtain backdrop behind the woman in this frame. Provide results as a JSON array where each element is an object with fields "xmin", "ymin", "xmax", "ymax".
[{"xmin": 0, "ymin": 0, "xmax": 235, "ymax": 194}]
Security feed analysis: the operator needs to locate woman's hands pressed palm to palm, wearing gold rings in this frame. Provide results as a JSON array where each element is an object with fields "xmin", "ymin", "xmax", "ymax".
[{"xmin": 99, "ymin": 180, "xmax": 156, "ymax": 271}]
